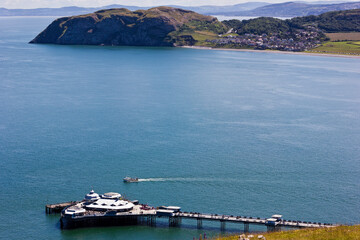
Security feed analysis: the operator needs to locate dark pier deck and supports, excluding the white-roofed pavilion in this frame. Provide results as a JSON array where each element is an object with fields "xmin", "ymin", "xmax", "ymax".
[{"xmin": 46, "ymin": 202, "xmax": 337, "ymax": 232}]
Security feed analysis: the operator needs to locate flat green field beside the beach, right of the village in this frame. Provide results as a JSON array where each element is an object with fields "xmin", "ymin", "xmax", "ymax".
[{"xmin": 308, "ymin": 41, "xmax": 360, "ymax": 55}]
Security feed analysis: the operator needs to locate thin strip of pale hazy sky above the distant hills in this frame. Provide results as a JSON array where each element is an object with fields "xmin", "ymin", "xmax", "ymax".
[{"xmin": 0, "ymin": 0, "xmax": 358, "ymax": 8}]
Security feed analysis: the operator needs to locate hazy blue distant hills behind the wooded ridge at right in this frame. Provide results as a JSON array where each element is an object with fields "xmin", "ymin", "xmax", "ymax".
[{"xmin": 224, "ymin": 2, "xmax": 360, "ymax": 17}]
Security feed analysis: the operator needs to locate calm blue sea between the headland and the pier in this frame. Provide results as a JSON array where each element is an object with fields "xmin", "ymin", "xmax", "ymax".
[{"xmin": 0, "ymin": 17, "xmax": 360, "ymax": 240}]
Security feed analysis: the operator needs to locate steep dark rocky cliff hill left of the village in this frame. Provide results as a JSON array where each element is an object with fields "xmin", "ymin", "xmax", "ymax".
[{"xmin": 30, "ymin": 7, "xmax": 219, "ymax": 46}]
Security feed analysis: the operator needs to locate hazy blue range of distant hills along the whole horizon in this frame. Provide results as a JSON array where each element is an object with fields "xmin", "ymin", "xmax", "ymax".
[{"xmin": 0, "ymin": 1, "xmax": 360, "ymax": 17}]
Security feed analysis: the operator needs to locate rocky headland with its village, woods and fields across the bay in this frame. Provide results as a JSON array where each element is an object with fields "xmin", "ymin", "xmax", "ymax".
[{"xmin": 30, "ymin": 7, "xmax": 360, "ymax": 55}]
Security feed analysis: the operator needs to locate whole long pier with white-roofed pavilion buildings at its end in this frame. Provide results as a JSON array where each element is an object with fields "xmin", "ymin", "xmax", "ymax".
[{"xmin": 46, "ymin": 190, "xmax": 337, "ymax": 232}]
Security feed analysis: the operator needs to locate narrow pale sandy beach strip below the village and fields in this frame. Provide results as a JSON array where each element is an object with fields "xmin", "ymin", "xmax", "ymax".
[{"xmin": 180, "ymin": 46, "xmax": 360, "ymax": 59}]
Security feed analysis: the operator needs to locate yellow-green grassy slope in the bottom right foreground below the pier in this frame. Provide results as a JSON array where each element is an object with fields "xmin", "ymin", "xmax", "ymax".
[{"xmin": 215, "ymin": 225, "xmax": 360, "ymax": 240}]
